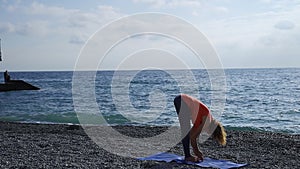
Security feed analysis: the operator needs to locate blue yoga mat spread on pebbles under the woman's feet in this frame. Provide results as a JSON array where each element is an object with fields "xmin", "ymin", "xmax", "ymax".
[{"xmin": 138, "ymin": 153, "xmax": 248, "ymax": 169}]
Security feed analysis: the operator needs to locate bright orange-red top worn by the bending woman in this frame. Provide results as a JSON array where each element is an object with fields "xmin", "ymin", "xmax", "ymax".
[{"xmin": 181, "ymin": 94, "xmax": 212, "ymax": 127}]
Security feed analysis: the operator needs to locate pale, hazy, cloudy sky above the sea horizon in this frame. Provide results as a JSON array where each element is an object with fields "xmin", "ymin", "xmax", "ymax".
[{"xmin": 0, "ymin": 0, "xmax": 300, "ymax": 71}]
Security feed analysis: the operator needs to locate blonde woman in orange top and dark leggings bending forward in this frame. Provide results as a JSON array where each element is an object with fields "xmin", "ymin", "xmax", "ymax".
[{"xmin": 174, "ymin": 94, "xmax": 226, "ymax": 162}]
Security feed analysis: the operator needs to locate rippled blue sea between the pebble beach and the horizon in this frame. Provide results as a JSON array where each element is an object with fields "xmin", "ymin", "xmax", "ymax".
[{"xmin": 0, "ymin": 68, "xmax": 300, "ymax": 134}]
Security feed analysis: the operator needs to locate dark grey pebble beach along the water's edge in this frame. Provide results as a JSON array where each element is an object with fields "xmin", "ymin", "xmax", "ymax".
[{"xmin": 0, "ymin": 122, "xmax": 300, "ymax": 169}]
